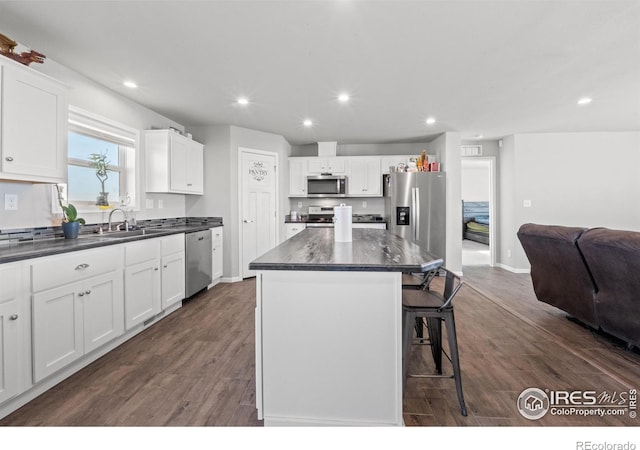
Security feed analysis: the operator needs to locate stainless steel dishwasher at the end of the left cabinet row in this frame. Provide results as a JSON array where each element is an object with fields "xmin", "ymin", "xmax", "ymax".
[{"xmin": 185, "ymin": 230, "xmax": 212, "ymax": 298}]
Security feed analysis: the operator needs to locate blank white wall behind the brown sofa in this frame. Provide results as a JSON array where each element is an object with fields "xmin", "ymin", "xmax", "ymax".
[{"xmin": 501, "ymin": 132, "xmax": 640, "ymax": 270}]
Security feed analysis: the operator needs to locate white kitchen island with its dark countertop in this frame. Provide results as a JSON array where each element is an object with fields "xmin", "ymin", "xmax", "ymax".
[{"xmin": 249, "ymin": 228, "xmax": 442, "ymax": 426}]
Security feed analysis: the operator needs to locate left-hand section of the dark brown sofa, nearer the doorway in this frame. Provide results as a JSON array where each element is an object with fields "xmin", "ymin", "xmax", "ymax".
[{"xmin": 518, "ymin": 223, "xmax": 598, "ymax": 328}]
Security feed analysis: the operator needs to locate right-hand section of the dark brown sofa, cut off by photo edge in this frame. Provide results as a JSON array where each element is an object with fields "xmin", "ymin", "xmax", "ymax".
[{"xmin": 578, "ymin": 228, "xmax": 640, "ymax": 346}]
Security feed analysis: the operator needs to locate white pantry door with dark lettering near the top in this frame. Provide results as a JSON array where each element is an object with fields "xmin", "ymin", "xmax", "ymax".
[{"xmin": 240, "ymin": 149, "xmax": 278, "ymax": 278}]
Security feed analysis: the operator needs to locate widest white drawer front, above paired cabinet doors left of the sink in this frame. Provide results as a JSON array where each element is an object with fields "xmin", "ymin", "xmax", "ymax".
[{"xmin": 31, "ymin": 245, "xmax": 123, "ymax": 292}]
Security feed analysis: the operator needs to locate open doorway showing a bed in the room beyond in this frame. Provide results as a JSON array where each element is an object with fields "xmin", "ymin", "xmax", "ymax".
[{"xmin": 461, "ymin": 156, "xmax": 497, "ymax": 267}]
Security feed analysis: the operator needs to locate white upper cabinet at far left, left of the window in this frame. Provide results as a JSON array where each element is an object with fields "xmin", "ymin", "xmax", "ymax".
[{"xmin": 0, "ymin": 57, "xmax": 68, "ymax": 183}]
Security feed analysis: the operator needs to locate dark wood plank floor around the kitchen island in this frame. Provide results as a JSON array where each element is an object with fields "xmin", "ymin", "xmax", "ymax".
[{"xmin": 0, "ymin": 267, "xmax": 640, "ymax": 426}]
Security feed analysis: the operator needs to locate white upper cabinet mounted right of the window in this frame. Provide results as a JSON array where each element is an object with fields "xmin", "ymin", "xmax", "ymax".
[{"xmin": 144, "ymin": 130, "xmax": 204, "ymax": 195}]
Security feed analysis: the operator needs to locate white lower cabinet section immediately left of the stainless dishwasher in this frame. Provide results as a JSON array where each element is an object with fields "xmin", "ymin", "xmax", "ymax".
[{"xmin": 160, "ymin": 233, "xmax": 185, "ymax": 309}]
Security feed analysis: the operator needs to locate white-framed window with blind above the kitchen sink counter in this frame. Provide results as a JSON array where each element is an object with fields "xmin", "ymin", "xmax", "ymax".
[{"xmin": 65, "ymin": 107, "xmax": 139, "ymax": 212}]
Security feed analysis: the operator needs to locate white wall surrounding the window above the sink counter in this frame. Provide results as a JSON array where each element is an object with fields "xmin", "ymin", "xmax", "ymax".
[{"xmin": 0, "ymin": 59, "xmax": 185, "ymax": 229}]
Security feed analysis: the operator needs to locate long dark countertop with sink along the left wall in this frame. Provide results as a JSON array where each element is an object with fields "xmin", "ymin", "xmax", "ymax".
[{"xmin": 0, "ymin": 222, "xmax": 222, "ymax": 264}]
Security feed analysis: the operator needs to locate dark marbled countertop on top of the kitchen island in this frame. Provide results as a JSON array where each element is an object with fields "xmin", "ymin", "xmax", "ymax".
[{"xmin": 249, "ymin": 228, "xmax": 443, "ymax": 272}]
